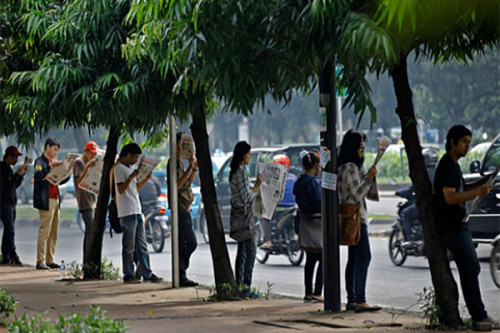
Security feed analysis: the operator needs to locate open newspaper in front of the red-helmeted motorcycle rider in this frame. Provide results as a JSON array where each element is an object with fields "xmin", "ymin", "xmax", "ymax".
[{"xmin": 253, "ymin": 163, "xmax": 286, "ymax": 220}]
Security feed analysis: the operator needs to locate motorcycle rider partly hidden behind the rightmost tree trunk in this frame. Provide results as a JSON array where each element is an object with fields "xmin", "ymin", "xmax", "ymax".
[{"xmin": 400, "ymin": 148, "xmax": 438, "ymax": 241}]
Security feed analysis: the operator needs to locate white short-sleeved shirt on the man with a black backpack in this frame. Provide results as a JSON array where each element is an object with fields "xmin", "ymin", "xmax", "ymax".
[{"xmin": 113, "ymin": 163, "xmax": 141, "ymax": 217}]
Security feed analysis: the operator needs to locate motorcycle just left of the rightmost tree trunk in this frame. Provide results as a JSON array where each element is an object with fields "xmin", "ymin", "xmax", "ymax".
[{"xmin": 389, "ymin": 186, "xmax": 425, "ymax": 266}]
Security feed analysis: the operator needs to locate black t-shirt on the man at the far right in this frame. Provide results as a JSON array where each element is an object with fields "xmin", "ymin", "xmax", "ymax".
[{"xmin": 434, "ymin": 154, "xmax": 467, "ymax": 234}]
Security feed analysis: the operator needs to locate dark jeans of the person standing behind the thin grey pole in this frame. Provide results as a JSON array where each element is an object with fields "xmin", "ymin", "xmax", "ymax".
[{"xmin": 179, "ymin": 211, "xmax": 198, "ymax": 282}]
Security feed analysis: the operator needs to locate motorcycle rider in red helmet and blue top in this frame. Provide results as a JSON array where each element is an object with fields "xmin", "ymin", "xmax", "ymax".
[{"xmin": 260, "ymin": 154, "xmax": 297, "ymax": 249}]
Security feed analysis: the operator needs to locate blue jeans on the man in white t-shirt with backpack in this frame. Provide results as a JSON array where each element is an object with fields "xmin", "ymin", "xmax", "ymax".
[{"xmin": 120, "ymin": 214, "xmax": 153, "ymax": 279}]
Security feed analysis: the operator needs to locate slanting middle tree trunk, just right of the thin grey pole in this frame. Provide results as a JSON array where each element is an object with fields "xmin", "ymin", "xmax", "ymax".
[{"xmin": 191, "ymin": 107, "xmax": 239, "ymax": 299}]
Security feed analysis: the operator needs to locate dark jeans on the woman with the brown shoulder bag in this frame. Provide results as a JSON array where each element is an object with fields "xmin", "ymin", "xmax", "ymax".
[{"xmin": 345, "ymin": 223, "xmax": 372, "ymax": 304}]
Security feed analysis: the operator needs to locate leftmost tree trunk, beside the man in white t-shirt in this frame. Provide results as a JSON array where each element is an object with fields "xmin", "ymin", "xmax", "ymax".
[{"xmin": 83, "ymin": 125, "xmax": 120, "ymax": 280}]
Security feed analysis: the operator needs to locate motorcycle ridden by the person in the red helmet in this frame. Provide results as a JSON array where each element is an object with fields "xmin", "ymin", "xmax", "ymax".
[{"xmin": 256, "ymin": 207, "xmax": 304, "ymax": 266}]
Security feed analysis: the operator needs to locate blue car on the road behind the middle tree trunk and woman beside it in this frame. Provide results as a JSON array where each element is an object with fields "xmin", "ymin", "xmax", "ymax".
[{"xmin": 197, "ymin": 144, "xmax": 319, "ymax": 243}]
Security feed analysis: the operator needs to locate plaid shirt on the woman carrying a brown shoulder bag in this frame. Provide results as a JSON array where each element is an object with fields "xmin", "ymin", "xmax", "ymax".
[{"xmin": 338, "ymin": 162, "xmax": 379, "ymax": 224}]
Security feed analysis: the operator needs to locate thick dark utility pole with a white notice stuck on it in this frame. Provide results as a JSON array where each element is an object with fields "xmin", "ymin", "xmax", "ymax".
[{"xmin": 319, "ymin": 60, "xmax": 340, "ymax": 312}]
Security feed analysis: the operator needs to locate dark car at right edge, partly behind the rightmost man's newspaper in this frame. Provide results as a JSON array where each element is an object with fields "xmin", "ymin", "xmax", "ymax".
[{"xmin": 464, "ymin": 134, "xmax": 500, "ymax": 243}]
